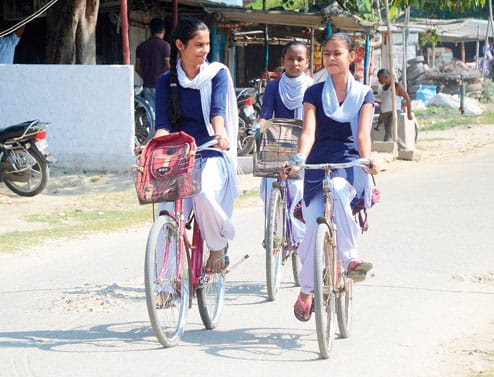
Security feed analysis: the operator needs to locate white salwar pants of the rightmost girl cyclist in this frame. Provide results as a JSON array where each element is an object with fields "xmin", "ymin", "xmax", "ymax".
[{"xmin": 298, "ymin": 177, "xmax": 359, "ymax": 294}]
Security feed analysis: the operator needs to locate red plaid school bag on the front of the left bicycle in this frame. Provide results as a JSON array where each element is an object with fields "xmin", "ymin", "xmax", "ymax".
[{"xmin": 135, "ymin": 132, "xmax": 202, "ymax": 204}]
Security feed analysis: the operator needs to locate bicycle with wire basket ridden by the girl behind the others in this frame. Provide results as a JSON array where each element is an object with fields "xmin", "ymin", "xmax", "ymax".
[{"xmin": 254, "ymin": 118, "xmax": 302, "ymax": 301}]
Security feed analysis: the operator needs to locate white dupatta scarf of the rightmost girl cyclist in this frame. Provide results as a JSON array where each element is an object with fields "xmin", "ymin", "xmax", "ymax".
[{"xmin": 322, "ymin": 75, "xmax": 373, "ymax": 208}]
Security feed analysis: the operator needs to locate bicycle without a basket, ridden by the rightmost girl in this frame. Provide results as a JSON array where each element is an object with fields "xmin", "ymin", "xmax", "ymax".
[{"xmin": 297, "ymin": 158, "xmax": 370, "ymax": 359}]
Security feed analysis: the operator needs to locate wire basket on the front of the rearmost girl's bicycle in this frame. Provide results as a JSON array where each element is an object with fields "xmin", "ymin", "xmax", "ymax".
[{"xmin": 253, "ymin": 118, "xmax": 302, "ymax": 178}]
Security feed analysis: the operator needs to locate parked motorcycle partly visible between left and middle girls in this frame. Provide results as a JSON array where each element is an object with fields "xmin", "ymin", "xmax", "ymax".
[{"xmin": 236, "ymin": 88, "xmax": 259, "ymax": 156}]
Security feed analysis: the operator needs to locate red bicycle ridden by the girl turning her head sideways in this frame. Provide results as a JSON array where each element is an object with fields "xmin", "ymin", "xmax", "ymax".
[{"xmin": 144, "ymin": 140, "xmax": 228, "ymax": 347}]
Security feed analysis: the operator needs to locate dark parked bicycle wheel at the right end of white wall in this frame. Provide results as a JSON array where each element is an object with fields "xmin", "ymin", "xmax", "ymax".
[{"xmin": 134, "ymin": 86, "xmax": 155, "ymax": 147}]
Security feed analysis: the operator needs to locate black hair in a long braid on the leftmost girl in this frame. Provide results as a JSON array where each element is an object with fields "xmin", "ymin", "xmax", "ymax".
[{"xmin": 168, "ymin": 18, "xmax": 209, "ymax": 130}]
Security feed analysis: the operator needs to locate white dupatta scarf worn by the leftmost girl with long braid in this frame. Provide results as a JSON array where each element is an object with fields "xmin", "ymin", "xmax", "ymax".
[{"xmin": 177, "ymin": 59, "xmax": 238, "ymax": 198}]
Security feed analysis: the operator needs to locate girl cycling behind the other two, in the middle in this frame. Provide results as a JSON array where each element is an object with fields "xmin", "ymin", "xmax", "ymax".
[{"xmin": 259, "ymin": 41, "xmax": 312, "ymax": 247}]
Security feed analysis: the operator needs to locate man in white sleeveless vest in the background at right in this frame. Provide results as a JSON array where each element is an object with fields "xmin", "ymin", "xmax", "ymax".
[{"xmin": 376, "ymin": 68, "xmax": 413, "ymax": 141}]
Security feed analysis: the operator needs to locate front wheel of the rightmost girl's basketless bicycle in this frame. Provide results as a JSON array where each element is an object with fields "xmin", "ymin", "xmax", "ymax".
[{"xmin": 314, "ymin": 223, "xmax": 336, "ymax": 359}]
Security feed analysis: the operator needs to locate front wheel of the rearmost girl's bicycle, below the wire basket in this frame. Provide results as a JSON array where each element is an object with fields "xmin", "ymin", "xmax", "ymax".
[{"xmin": 264, "ymin": 187, "xmax": 285, "ymax": 301}]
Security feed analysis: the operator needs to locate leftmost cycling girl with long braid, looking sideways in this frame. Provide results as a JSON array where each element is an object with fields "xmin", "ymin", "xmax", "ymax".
[{"xmin": 155, "ymin": 19, "xmax": 238, "ymax": 272}]
